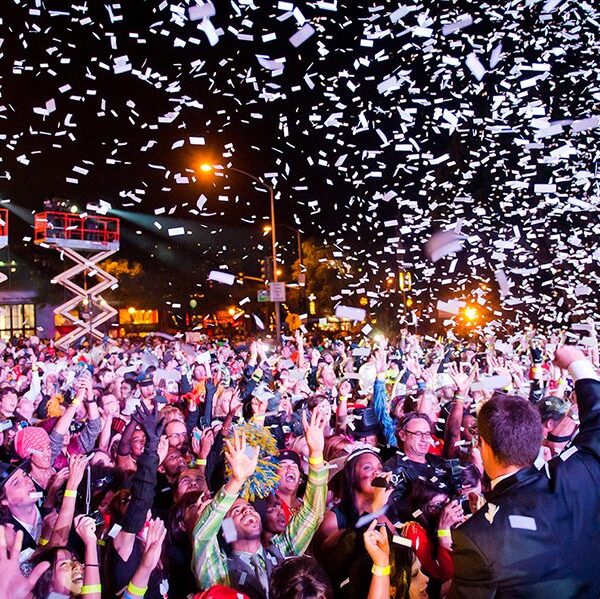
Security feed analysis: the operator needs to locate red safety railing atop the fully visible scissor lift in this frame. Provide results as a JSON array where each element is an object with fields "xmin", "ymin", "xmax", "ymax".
[{"xmin": 33, "ymin": 212, "xmax": 120, "ymax": 245}]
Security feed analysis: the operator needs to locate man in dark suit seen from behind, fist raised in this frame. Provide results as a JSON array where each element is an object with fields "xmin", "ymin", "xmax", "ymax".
[{"xmin": 450, "ymin": 346, "xmax": 600, "ymax": 599}]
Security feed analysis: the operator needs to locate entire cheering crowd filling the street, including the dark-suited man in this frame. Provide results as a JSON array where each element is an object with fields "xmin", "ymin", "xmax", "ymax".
[{"xmin": 0, "ymin": 324, "xmax": 600, "ymax": 599}]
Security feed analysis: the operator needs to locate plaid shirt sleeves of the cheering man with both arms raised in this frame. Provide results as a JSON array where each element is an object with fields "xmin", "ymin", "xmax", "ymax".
[{"xmin": 192, "ymin": 464, "xmax": 327, "ymax": 590}]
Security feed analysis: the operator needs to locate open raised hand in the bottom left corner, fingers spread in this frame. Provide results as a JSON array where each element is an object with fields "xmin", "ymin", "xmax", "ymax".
[{"xmin": 0, "ymin": 525, "xmax": 50, "ymax": 599}]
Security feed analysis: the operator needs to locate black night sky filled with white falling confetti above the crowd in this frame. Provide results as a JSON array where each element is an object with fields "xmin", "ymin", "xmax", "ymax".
[{"xmin": 0, "ymin": 0, "xmax": 600, "ymax": 332}]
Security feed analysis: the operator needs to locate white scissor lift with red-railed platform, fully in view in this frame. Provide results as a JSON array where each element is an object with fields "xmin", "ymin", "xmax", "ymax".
[{"xmin": 34, "ymin": 212, "xmax": 120, "ymax": 349}]
